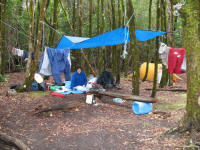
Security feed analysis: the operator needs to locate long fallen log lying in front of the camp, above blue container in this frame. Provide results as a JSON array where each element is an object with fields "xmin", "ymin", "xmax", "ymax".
[{"xmin": 91, "ymin": 91, "xmax": 157, "ymax": 103}]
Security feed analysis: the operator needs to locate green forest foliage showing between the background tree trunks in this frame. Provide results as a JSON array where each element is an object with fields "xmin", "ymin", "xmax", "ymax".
[{"xmin": 0, "ymin": 0, "xmax": 183, "ymax": 74}]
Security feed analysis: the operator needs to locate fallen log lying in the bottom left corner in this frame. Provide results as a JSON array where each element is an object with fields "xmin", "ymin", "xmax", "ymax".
[{"xmin": 0, "ymin": 131, "xmax": 30, "ymax": 150}]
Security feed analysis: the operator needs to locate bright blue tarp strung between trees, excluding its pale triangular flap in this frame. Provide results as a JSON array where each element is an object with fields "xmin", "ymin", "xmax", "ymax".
[{"xmin": 57, "ymin": 27, "xmax": 166, "ymax": 49}]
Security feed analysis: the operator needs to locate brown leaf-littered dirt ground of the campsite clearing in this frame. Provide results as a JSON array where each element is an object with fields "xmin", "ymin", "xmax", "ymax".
[{"xmin": 0, "ymin": 73, "xmax": 197, "ymax": 150}]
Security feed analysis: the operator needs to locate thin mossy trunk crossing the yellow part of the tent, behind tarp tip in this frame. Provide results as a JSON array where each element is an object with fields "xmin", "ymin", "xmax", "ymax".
[{"xmin": 142, "ymin": 0, "xmax": 152, "ymax": 81}]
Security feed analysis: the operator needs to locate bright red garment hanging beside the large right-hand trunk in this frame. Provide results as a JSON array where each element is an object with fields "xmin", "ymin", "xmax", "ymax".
[{"xmin": 168, "ymin": 48, "xmax": 185, "ymax": 74}]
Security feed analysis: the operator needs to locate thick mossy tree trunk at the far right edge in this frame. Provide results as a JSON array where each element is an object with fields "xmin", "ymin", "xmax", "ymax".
[{"xmin": 181, "ymin": 0, "xmax": 200, "ymax": 131}]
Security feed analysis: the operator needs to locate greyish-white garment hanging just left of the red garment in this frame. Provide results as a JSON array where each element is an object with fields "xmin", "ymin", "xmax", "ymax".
[{"xmin": 159, "ymin": 42, "xmax": 170, "ymax": 68}]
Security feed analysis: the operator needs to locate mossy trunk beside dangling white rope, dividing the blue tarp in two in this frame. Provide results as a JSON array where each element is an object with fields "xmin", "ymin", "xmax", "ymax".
[{"xmin": 127, "ymin": 0, "xmax": 140, "ymax": 95}]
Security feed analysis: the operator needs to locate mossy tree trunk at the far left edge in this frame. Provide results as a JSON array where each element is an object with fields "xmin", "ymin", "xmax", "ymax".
[{"xmin": 0, "ymin": 0, "xmax": 7, "ymax": 75}]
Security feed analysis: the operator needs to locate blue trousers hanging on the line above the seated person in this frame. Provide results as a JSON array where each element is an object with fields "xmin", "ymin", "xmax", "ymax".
[{"xmin": 47, "ymin": 47, "xmax": 71, "ymax": 85}]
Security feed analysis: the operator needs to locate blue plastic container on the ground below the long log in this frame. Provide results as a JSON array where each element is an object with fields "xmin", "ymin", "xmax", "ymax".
[{"xmin": 132, "ymin": 101, "xmax": 153, "ymax": 115}]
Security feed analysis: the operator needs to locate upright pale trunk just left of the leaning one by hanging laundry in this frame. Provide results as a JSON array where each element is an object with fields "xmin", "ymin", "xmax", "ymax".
[{"xmin": 26, "ymin": 0, "xmax": 34, "ymax": 77}]
